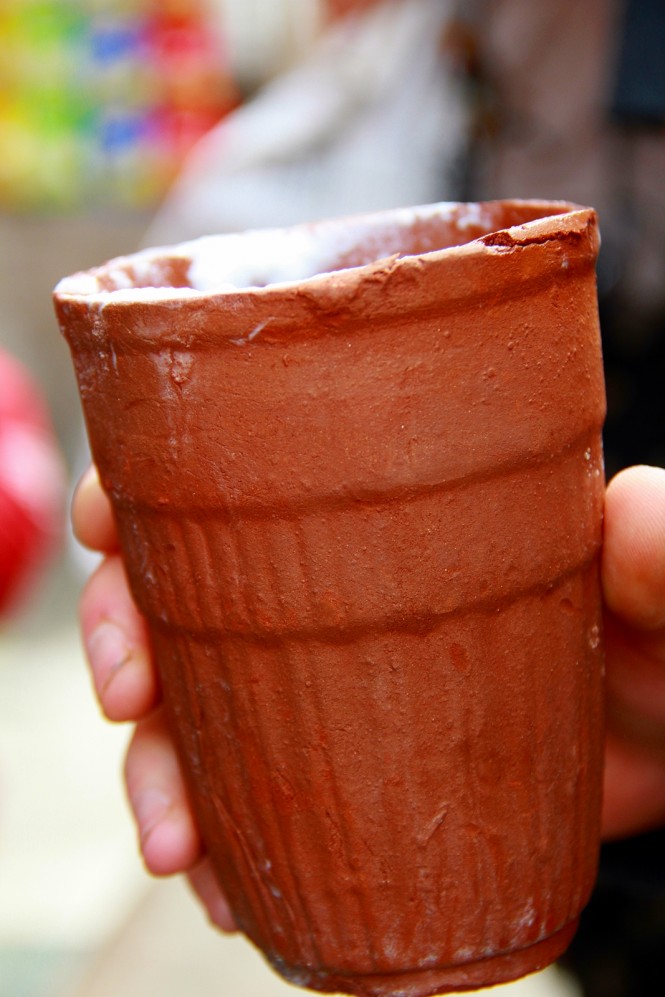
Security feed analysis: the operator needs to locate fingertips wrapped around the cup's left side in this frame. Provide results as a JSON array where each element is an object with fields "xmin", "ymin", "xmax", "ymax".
[{"xmin": 72, "ymin": 468, "xmax": 235, "ymax": 931}]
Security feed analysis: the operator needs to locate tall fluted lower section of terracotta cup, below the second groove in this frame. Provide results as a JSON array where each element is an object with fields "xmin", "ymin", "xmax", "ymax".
[{"xmin": 153, "ymin": 562, "xmax": 601, "ymax": 973}]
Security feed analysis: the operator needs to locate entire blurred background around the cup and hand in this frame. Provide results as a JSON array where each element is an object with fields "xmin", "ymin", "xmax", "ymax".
[{"xmin": 0, "ymin": 0, "xmax": 665, "ymax": 997}]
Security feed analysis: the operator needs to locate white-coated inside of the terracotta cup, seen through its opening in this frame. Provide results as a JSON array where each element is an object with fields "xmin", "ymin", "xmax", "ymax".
[{"xmin": 58, "ymin": 201, "xmax": 571, "ymax": 296}]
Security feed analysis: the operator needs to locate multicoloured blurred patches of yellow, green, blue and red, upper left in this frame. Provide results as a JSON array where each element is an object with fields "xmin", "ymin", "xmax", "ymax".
[{"xmin": 0, "ymin": 0, "xmax": 237, "ymax": 211}]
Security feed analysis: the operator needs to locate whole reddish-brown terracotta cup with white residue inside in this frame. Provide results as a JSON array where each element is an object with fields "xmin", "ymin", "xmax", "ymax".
[{"xmin": 55, "ymin": 201, "xmax": 604, "ymax": 997}]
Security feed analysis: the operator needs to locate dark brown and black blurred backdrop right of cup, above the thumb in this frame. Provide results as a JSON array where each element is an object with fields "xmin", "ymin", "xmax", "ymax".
[{"xmin": 458, "ymin": 0, "xmax": 665, "ymax": 473}]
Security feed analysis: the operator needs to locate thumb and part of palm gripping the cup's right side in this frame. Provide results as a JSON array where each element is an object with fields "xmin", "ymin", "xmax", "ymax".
[{"xmin": 602, "ymin": 467, "xmax": 665, "ymax": 838}]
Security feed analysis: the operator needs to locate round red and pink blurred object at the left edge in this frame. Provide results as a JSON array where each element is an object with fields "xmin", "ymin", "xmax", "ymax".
[{"xmin": 0, "ymin": 351, "xmax": 65, "ymax": 617}]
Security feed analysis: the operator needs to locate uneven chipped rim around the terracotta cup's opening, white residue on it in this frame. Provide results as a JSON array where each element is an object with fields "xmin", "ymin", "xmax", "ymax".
[{"xmin": 53, "ymin": 198, "xmax": 597, "ymax": 309}]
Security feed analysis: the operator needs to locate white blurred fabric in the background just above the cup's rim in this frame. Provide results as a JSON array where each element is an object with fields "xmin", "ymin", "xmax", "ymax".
[{"xmin": 144, "ymin": 0, "xmax": 468, "ymax": 245}]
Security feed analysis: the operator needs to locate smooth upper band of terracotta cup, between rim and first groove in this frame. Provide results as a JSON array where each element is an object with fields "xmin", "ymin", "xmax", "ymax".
[{"xmin": 59, "ymin": 242, "xmax": 604, "ymax": 516}]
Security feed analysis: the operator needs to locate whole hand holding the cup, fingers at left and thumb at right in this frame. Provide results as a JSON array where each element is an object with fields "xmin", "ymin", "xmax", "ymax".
[{"xmin": 72, "ymin": 467, "xmax": 665, "ymax": 931}]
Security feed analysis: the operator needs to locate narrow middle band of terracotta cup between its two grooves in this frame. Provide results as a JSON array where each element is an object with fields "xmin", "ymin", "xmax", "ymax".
[{"xmin": 118, "ymin": 433, "xmax": 602, "ymax": 634}]
